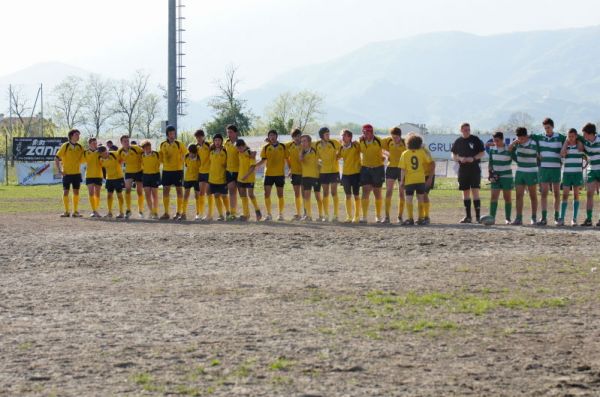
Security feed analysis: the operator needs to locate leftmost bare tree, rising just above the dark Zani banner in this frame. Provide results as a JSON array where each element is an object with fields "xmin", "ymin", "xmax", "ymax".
[{"xmin": 53, "ymin": 76, "xmax": 85, "ymax": 130}]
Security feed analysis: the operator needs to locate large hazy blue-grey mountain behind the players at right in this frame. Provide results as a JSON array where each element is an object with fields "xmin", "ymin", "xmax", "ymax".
[{"xmin": 233, "ymin": 26, "xmax": 600, "ymax": 129}]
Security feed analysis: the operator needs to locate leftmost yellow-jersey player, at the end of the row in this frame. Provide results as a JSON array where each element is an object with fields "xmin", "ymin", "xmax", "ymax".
[{"xmin": 54, "ymin": 130, "xmax": 85, "ymax": 218}]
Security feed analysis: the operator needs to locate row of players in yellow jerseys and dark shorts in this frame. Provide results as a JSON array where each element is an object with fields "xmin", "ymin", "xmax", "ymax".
[{"xmin": 56, "ymin": 124, "xmax": 435, "ymax": 225}]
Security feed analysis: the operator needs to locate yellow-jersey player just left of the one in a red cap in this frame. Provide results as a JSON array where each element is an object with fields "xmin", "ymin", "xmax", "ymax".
[{"xmin": 339, "ymin": 130, "xmax": 361, "ymax": 223}]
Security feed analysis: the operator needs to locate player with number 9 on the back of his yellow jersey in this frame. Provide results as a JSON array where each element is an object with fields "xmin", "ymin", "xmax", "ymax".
[{"xmin": 399, "ymin": 134, "xmax": 435, "ymax": 226}]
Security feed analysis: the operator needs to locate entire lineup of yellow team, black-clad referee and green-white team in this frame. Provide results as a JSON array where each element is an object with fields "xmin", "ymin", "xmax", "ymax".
[{"xmin": 55, "ymin": 119, "xmax": 600, "ymax": 226}]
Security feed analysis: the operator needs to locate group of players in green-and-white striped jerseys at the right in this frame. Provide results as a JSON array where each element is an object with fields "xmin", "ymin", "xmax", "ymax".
[{"xmin": 488, "ymin": 118, "xmax": 600, "ymax": 227}]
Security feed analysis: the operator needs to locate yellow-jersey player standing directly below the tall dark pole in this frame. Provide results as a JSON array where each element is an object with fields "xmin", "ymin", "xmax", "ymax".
[{"xmin": 159, "ymin": 126, "xmax": 187, "ymax": 219}]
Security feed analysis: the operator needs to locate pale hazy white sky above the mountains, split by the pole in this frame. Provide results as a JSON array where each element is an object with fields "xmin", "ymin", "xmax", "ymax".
[{"xmin": 0, "ymin": 0, "xmax": 600, "ymax": 99}]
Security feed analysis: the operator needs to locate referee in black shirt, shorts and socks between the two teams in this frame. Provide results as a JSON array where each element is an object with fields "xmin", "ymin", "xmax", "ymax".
[{"xmin": 452, "ymin": 123, "xmax": 485, "ymax": 223}]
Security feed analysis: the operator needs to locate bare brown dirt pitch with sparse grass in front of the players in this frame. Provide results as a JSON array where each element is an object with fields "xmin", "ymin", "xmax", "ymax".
[{"xmin": 0, "ymin": 206, "xmax": 600, "ymax": 397}]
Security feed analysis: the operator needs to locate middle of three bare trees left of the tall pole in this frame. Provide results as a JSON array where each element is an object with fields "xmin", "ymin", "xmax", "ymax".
[{"xmin": 83, "ymin": 74, "xmax": 114, "ymax": 138}]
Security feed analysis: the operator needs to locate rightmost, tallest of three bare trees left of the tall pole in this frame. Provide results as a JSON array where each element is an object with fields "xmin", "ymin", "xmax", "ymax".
[{"xmin": 114, "ymin": 70, "xmax": 150, "ymax": 136}]
